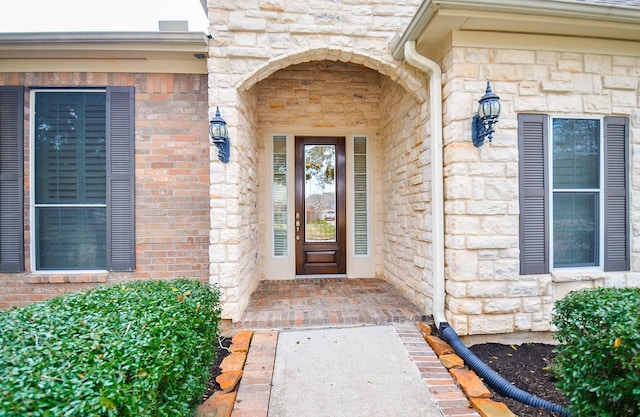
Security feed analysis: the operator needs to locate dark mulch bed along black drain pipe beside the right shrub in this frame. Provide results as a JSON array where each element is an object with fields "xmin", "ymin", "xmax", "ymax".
[{"xmin": 469, "ymin": 343, "xmax": 568, "ymax": 417}]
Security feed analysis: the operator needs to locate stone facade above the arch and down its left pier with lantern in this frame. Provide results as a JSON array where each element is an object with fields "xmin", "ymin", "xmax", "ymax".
[{"xmin": 207, "ymin": 0, "xmax": 425, "ymax": 320}]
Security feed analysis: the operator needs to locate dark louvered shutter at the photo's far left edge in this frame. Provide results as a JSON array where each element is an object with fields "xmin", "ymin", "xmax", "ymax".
[{"xmin": 0, "ymin": 86, "xmax": 24, "ymax": 272}]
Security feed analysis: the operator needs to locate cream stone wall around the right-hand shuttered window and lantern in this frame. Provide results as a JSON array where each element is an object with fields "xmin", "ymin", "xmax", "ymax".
[{"xmin": 442, "ymin": 43, "xmax": 640, "ymax": 335}]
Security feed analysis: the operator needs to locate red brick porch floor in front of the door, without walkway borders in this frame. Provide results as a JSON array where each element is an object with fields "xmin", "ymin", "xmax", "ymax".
[{"xmin": 237, "ymin": 278, "xmax": 431, "ymax": 330}]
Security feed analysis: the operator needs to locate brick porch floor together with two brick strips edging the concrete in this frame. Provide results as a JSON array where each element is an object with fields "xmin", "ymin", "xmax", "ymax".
[{"xmin": 231, "ymin": 278, "xmax": 480, "ymax": 417}]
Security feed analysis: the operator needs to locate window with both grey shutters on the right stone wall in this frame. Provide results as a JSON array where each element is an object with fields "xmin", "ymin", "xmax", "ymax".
[{"xmin": 518, "ymin": 114, "xmax": 630, "ymax": 274}]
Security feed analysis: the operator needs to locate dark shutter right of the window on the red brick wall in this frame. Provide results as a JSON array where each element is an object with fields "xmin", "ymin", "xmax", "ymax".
[{"xmin": 107, "ymin": 87, "xmax": 135, "ymax": 271}]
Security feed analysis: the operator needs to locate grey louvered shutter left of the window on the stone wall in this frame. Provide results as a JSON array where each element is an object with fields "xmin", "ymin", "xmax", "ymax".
[{"xmin": 518, "ymin": 114, "xmax": 549, "ymax": 275}]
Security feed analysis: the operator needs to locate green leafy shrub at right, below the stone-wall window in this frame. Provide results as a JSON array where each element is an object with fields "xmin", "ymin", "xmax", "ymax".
[{"xmin": 553, "ymin": 288, "xmax": 640, "ymax": 417}]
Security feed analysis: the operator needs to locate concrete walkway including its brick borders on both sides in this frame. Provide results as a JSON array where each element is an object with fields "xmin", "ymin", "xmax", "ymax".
[{"xmin": 231, "ymin": 323, "xmax": 480, "ymax": 417}]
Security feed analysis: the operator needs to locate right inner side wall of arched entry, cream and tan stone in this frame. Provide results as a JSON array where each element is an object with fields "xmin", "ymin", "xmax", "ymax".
[{"xmin": 380, "ymin": 75, "xmax": 433, "ymax": 311}]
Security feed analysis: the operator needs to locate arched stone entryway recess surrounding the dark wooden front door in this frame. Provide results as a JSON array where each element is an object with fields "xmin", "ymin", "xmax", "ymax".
[{"xmin": 212, "ymin": 48, "xmax": 432, "ymax": 321}]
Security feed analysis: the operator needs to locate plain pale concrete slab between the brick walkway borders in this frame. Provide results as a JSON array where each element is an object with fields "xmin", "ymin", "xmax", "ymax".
[{"xmin": 268, "ymin": 326, "xmax": 441, "ymax": 417}]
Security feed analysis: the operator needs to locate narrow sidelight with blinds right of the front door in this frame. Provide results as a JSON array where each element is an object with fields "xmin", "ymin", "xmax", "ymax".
[{"xmin": 353, "ymin": 136, "xmax": 369, "ymax": 255}]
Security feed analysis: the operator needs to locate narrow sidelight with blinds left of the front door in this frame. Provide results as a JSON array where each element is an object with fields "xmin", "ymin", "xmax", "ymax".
[{"xmin": 272, "ymin": 136, "xmax": 288, "ymax": 256}]
